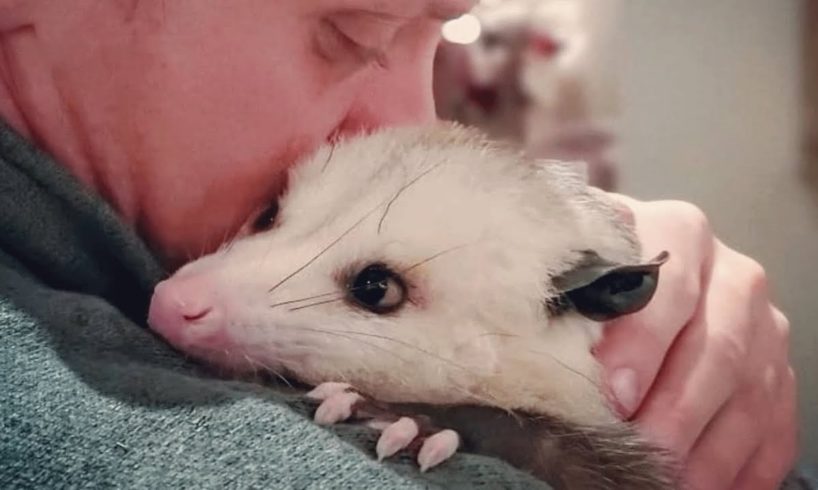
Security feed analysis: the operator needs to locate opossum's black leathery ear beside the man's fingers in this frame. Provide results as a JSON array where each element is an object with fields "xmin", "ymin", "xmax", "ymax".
[{"xmin": 553, "ymin": 252, "xmax": 670, "ymax": 322}]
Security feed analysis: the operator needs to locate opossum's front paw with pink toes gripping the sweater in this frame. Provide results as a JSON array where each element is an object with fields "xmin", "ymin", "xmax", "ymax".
[{"xmin": 307, "ymin": 382, "xmax": 460, "ymax": 471}]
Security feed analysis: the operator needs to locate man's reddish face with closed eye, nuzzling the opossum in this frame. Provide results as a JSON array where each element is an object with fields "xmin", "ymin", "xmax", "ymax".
[{"xmin": 28, "ymin": 0, "xmax": 472, "ymax": 263}]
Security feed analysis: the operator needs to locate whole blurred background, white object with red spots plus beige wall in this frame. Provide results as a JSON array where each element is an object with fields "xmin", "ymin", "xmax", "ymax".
[{"xmin": 434, "ymin": 0, "xmax": 818, "ymax": 464}]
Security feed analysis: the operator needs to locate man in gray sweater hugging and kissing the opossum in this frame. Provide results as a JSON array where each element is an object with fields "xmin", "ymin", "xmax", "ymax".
[{"xmin": 0, "ymin": 0, "xmax": 796, "ymax": 489}]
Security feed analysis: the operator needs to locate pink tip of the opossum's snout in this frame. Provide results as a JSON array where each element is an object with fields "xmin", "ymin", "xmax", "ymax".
[{"xmin": 148, "ymin": 276, "xmax": 229, "ymax": 349}]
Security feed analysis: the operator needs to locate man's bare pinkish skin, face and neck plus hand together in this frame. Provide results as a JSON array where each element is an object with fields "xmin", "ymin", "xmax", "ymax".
[{"xmin": 0, "ymin": 0, "xmax": 796, "ymax": 490}]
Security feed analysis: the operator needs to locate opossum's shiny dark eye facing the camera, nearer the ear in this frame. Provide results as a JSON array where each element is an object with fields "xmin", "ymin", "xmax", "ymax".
[{"xmin": 348, "ymin": 263, "xmax": 406, "ymax": 313}]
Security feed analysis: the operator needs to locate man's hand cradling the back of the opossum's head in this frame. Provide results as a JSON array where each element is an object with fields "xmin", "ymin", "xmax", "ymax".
[{"xmin": 596, "ymin": 195, "xmax": 797, "ymax": 490}]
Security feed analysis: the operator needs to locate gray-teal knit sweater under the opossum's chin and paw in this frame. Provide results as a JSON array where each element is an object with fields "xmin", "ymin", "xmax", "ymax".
[{"xmin": 0, "ymin": 122, "xmax": 545, "ymax": 489}]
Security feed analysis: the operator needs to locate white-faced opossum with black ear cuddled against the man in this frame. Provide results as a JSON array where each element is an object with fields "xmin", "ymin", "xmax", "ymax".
[{"xmin": 149, "ymin": 123, "xmax": 672, "ymax": 489}]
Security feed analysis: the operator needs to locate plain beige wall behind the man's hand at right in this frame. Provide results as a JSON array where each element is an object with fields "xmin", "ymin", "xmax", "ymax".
[{"xmin": 620, "ymin": 0, "xmax": 818, "ymax": 462}]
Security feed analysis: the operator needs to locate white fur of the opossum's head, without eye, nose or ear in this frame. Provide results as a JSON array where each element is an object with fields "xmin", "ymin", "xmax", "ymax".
[{"xmin": 159, "ymin": 124, "xmax": 640, "ymax": 424}]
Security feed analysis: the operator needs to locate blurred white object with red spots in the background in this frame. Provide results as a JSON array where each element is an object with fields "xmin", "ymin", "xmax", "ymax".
[{"xmin": 435, "ymin": 0, "xmax": 622, "ymax": 186}]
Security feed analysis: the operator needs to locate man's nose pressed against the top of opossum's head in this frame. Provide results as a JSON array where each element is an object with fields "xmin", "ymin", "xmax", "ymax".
[{"xmin": 337, "ymin": 54, "xmax": 435, "ymax": 134}]
